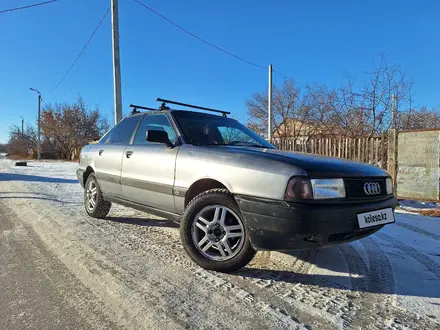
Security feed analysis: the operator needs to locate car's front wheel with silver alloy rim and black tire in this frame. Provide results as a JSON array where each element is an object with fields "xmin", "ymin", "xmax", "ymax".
[{"xmin": 180, "ymin": 189, "xmax": 256, "ymax": 273}]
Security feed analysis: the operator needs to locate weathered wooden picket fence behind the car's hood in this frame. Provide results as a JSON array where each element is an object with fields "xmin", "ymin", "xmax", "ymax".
[{"xmin": 272, "ymin": 134, "xmax": 388, "ymax": 169}]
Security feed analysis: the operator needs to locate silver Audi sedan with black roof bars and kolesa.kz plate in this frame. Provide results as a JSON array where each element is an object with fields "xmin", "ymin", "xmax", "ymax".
[{"xmin": 77, "ymin": 99, "xmax": 397, "ymax": 272}]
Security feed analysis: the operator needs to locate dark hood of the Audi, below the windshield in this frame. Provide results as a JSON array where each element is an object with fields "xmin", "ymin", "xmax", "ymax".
[{"xmin": 208, "ymin": 146, "xmax": 388, "ymax": 178}]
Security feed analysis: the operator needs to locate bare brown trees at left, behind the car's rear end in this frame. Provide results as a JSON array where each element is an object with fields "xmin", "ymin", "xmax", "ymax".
[{"xmin": 8, "ymin": 96, "xmax": 109, "ymax": 159}]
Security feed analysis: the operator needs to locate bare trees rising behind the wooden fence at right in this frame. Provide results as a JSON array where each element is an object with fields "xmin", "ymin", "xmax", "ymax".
[{"xmin": 246, "ymin": 54, "xmax": 440, "ymax": 138}]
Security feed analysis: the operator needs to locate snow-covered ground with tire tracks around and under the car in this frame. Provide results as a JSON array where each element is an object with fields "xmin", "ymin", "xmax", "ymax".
[{"xmin": 0, "ymin": 159, "xmax": 440, "ymax": 329}]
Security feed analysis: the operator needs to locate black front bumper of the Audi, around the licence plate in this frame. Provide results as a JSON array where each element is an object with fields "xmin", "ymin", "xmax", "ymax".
[{"xmin": 236, "ymin": 196, "xmax": 397, "ymax": 250}]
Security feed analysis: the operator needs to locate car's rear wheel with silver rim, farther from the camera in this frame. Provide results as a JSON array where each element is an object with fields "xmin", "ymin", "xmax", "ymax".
[{"xmin": 84, "ymin": 173, "xmax": 112, "ymax": 219}]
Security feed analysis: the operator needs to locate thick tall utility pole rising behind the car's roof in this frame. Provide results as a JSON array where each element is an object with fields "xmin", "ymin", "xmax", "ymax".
[{"xmin": 111, "ymin": 0, "xmax": 122, "ymax": 125}]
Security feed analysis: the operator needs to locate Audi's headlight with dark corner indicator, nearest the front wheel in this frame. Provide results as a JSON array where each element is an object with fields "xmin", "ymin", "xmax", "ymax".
[{"xmin": 286, "ymin": 177, "xmax": 346, "ymax": 201}]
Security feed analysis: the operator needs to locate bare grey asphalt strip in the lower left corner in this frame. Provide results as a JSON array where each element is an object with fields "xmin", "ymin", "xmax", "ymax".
[{"xmin": 0, "ymin": 200, "xmax": 114, "ymax": 330}]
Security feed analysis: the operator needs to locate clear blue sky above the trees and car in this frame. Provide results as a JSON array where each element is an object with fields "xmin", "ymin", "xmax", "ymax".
[{"xmin": 0, "ymin": 0, "xmax": 440, "ymax": 142}]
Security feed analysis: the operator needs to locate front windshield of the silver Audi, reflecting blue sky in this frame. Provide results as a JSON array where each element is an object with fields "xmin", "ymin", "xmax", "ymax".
[{"xmin": 172, "ymin": 111, "xmax": 275, "ymax": 149}]
